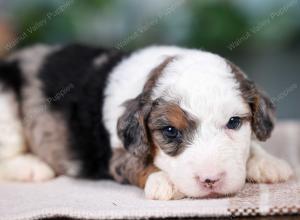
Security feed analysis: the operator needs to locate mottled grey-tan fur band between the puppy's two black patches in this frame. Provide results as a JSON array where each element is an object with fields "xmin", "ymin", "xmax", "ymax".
[{"xmin": 16, "ymin": 44, "xmax": 80, "ymax": 176}]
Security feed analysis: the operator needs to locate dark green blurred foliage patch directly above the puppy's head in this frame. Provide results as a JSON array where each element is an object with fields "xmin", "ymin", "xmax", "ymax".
[{"xmin": 186, "ymin": 1, "xmax": 249, "ymax": 51}]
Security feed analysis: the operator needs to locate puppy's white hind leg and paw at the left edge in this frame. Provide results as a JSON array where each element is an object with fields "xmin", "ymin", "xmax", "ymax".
[{"xmin": 0, "ymin": 88, "xmax": 54, "ymax": 181}]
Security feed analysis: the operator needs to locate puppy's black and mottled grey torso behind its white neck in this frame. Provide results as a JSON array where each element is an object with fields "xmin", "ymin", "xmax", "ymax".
[{"xmin": 1, "ymin": 45, "xmax": 125, "ymax": 178}]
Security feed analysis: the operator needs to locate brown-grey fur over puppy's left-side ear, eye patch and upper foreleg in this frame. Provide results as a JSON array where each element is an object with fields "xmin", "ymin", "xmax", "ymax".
[{"xmin": 110, "ymin": 57, "xmax": 196, "ymax": 187}]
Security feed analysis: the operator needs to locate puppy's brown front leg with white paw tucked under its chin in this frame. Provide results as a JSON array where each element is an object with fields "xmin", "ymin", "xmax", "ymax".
[{"xmin": 110, "ymin": 148, "xmax": 184, "ymax": 200}]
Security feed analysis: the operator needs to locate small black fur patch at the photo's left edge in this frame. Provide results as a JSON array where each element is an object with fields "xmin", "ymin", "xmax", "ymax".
[{"xmin": 0, "ymin": 61, "xmax": 25, "ymax": 101}]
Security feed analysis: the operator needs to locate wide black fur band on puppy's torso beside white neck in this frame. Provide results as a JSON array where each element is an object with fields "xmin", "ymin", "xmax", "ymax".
[{"xmin": 39, "ymin": 45, "xmax": 126, "ymax": 178}]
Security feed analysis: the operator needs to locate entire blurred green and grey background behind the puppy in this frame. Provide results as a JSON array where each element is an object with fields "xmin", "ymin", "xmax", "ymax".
[{"xmin": 0, "ymin": 0, "xmax": 300, "ymax": 119}]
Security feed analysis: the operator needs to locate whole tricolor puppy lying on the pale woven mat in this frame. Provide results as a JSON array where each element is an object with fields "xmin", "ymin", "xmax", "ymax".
[{"xmin": 0, "ymin": 45, "xmax": 292, "ymax": 200}]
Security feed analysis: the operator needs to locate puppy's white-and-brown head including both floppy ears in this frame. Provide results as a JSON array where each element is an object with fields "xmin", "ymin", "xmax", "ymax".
[{"xmin": 118, "ymin": 51, "xmax": 273, "ymax": 197}]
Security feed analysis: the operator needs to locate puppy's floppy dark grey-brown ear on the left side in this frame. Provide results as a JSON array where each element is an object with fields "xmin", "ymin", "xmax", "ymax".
[{"xmin": 117, "ymin": 96, "xmax": 151, "ymax": 157}]
